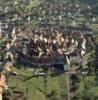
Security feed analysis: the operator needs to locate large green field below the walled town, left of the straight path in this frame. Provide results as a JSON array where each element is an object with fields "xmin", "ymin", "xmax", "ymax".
[{"xmin": 4, "ymin": 67, "xmax": 67, "ymax": 100}]
